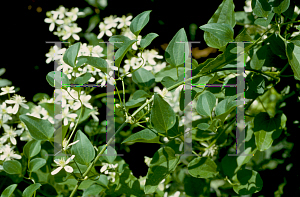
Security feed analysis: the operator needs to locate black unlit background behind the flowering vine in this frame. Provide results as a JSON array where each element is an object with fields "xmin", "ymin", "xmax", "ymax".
[{"xmin": 1, "ymin": 0, "xmax": 299, "ymax": 196}]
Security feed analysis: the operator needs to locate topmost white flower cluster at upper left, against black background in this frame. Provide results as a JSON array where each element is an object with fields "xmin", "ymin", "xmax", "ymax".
[{"xmin": 44, "ymin": 6, "xmax": 84, "ymax": 40}]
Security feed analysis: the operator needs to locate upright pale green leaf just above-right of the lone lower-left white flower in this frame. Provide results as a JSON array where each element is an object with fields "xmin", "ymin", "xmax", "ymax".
[{"xmin": 71, "ymin": 130, "xmax": 95, "ymax": 165}]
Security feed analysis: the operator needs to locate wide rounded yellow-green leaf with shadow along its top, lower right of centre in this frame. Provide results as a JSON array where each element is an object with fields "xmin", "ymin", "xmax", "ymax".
[{"xmin": 188, "ymin": 157, "xmax": 218, "ymax": 179}]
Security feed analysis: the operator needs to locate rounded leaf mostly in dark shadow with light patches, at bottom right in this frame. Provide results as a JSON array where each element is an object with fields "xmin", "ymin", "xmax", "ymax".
[{"xmin": 233, "ymin": 169, "xmax": 263, "ymax": 195}]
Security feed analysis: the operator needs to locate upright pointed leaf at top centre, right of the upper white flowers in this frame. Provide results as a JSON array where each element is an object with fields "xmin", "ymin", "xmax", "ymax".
[{"xmin": 129, "ymin": 10, "xmax": 152, "ymax": 36}]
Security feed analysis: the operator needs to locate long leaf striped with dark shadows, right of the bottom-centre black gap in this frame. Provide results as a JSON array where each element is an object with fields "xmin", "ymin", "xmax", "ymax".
[{"xmin": 144, "ymin": 146, "xmax": 179, "ymax": 194}]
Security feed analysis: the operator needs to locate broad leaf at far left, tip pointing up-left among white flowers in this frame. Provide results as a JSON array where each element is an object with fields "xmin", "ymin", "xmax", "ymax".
[{"xmin": 19, "ymin": 114, "xmax": 54, "ymax": 141}]
